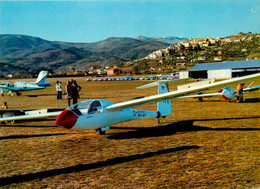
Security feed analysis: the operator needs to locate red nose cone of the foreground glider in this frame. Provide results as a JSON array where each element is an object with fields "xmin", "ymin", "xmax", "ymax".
[{"xmin": 55, "ymin": 109, "xmax": 78, "ymax": 129}]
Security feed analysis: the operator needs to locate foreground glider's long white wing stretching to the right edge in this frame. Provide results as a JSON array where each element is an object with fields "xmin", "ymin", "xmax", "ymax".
[{"xmin": 107, "ymin": 73, "xmax": 260, "ymax": 111}]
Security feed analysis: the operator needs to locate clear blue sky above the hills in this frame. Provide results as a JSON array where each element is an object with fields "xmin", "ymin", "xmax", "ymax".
[{"xmin": 0, "ymin": 0, "xmax": 260, "ymax": 42}]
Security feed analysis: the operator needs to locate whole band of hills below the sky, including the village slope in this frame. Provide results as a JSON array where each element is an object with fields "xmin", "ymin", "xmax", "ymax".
[{"xmin": 0, "ymin": 32, "xmax": 260, "ymax": 76}]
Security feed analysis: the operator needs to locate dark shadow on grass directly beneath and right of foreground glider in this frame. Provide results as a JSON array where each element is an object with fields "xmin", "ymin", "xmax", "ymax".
[{"xmin": 107, "ymin": 116, "xmax": 260, "ymax": 139}]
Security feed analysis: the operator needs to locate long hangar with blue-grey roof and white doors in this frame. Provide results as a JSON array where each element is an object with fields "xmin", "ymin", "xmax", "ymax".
[{"xmin": 180, "ymin": 59, "xmax": 260, "ymax": 79}]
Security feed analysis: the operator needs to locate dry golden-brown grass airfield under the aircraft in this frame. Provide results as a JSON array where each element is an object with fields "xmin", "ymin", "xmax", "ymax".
[{"xmin": 0, "ymin": 77, "xmax": 260, "ymax": 188}]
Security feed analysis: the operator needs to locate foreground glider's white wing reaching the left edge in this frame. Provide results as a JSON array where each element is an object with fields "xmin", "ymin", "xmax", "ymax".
[{"xmin": 0, "ymin": 111, "xmax": 61, "ymax": 122}]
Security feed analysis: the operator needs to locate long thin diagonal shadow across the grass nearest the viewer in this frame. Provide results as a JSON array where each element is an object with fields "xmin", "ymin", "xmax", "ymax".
[{"xmin": 0, "ymin": 146, "xmax": 199, "ymax": 186}]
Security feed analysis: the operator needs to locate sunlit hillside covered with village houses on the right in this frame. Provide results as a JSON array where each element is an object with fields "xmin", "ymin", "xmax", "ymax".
[{"xmin": 125, "ymin": 33, "xmax": 260, "ymax": 73}]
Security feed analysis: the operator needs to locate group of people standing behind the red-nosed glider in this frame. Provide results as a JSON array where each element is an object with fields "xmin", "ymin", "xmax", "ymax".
[{"xmin": 56, "ymin": 79, "xmax": 81, "ymax": 106}]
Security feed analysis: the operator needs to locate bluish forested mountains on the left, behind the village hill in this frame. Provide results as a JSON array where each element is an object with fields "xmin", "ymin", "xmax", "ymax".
[{"xmin": 0, "ymin": 34, "xmax": 173, "ymax": 75}]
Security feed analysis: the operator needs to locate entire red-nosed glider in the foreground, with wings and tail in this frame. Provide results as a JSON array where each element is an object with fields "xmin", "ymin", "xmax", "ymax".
[{"xmin": 0, "ymin": 73, "xmax": 260, "ymax": 134}]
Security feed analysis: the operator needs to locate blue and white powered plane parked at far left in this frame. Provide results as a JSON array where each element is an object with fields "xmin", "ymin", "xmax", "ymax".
[{"xmin": 0, "ymin": 71, "xmax": 51, "ymax": 96}]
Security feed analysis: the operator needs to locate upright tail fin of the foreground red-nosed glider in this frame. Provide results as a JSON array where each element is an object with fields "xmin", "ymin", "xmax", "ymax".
[{"xmin": 157, "ymin": 82, "xmax": 172, "ymax": 117}]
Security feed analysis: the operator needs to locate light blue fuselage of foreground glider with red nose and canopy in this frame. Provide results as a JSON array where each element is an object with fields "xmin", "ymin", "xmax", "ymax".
[{"xmin": 56, "ymin": 99, "xmax": 158, "ymax": 129}]
